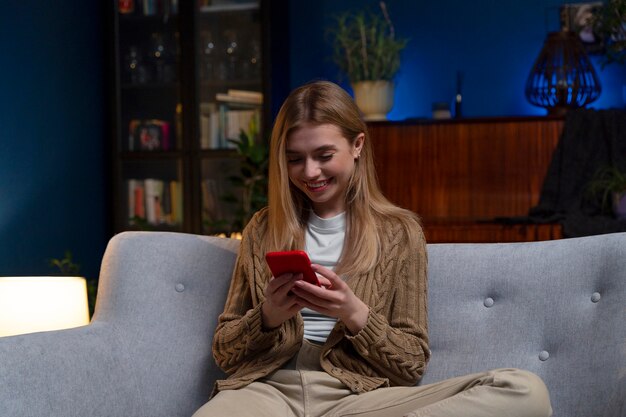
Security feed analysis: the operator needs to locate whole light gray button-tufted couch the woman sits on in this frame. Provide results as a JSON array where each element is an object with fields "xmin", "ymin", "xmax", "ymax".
[{"xmin": 0, "ymin": 232, "xmax": 626, "ymax": 417}]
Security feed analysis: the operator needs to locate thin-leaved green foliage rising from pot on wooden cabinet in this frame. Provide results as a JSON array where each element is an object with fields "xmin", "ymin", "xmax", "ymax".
[{"xmin": 327, "ymin": 2, "xmax": 408, "ymax": 83}]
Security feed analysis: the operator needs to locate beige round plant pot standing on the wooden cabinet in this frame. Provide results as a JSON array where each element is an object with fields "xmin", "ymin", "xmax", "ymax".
[{"xmin": 352, "ymin": 80, "xmax": 394, "ymax": 121}]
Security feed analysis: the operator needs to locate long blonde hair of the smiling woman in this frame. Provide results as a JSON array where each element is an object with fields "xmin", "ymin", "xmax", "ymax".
[{"xmin": 265, "ymin": 81, "xmax": 419, "ymax": 276}]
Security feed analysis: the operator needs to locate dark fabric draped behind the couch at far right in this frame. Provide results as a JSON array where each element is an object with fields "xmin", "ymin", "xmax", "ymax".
[{"xmin": 507, "ymin": 109, "xmax": 626, "ymax": 237}]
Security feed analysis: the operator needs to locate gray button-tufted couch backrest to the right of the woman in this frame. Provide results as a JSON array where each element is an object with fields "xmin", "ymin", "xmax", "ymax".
[{"xmin": 423, "ymin": 233, "xmax": 626, "ymax": 417}]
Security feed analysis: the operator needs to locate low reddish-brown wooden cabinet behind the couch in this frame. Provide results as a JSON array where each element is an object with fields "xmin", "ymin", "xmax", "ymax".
[{"xmin": 369, "ymin": 117, "xmax": 563, "ymax": 243}]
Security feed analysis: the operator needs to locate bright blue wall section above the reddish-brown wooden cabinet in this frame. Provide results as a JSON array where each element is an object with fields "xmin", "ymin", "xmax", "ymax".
[{"xmin": 290, "ymin": 0, "xmax": 626, "ymax": 120}]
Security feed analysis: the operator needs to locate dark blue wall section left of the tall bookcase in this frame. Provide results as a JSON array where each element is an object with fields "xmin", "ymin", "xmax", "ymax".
[{"xmin": 0, "ymin": 0, "xmax": 108, "ymax": 278}]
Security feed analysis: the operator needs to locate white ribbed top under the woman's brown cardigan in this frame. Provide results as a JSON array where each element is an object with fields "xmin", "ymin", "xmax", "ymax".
[{"xmin": 301, "ymin": 212, "xmax": 346, "ymax": 343}]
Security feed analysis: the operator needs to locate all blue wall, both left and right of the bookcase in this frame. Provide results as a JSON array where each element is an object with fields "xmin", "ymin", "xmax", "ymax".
[{"xmin": 0, "ymin": 0, "xmax": 626, "ymax": 277}]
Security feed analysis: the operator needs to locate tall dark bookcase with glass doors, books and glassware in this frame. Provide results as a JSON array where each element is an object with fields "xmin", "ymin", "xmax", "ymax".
[{"xmin": 109, "ymin": 0, "xmax": 288, "ymax": 234}]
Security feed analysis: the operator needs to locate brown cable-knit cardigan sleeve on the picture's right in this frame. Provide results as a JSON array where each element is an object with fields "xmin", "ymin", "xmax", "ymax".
[{"xmin": 346, "ymin": 219, "xmax": 430, "ymax": 385}]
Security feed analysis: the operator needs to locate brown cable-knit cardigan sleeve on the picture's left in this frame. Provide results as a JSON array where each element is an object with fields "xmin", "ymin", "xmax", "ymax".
[{"xmin": 213, "ymin": 208, "xmax": 284, "ymax": 374}]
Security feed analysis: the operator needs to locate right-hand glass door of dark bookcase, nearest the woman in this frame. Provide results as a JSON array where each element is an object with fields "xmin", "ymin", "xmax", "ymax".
[{"xmin": 195, "ymin": 0, "xmax": 263, "ymax": 233}]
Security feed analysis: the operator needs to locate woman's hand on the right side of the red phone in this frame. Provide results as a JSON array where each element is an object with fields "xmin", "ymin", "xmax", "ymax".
[{"xmin": 292, "ymin": 264, "xmax": 369, "ymax": 334}]
